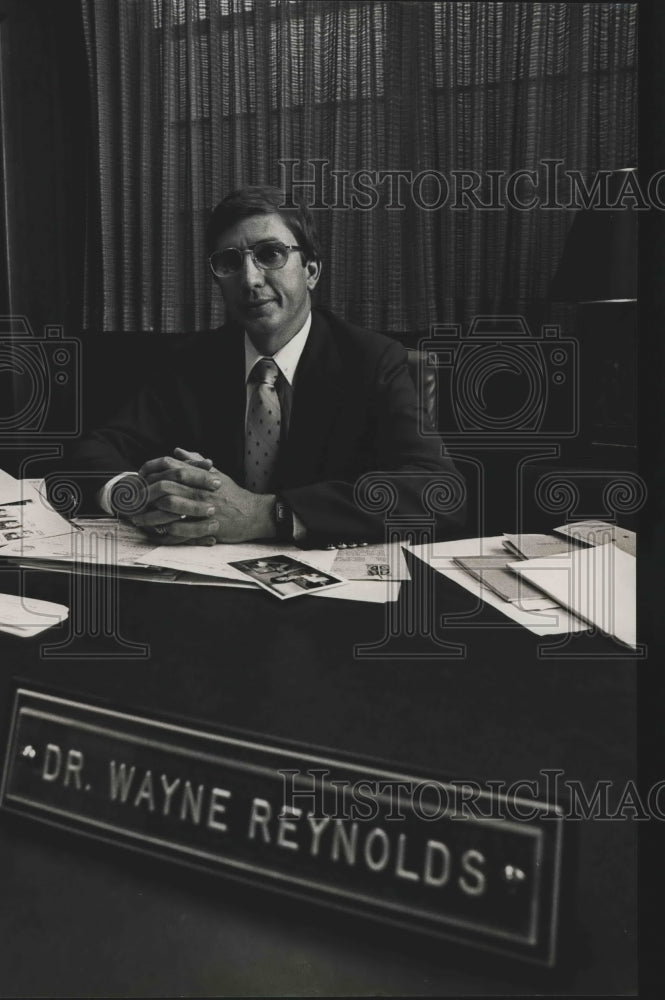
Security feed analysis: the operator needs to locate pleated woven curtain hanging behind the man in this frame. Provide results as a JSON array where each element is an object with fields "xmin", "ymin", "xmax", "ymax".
[{"xmin": 82, "ymin": 0, "xmax": 637, "ymax": 332}]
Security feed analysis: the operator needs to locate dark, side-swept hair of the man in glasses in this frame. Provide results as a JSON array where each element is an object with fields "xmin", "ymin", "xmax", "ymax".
[{"xmin": 206, "ymin": 185, "xmax": 321, "ymax": 262}]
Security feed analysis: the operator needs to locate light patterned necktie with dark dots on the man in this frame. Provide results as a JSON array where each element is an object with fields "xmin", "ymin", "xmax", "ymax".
[{"xmin": 245, "ymin": 358, "xmax": 282, "ymax": 493}]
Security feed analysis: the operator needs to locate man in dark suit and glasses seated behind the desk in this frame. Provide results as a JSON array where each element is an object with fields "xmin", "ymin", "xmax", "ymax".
[{"xmin": 63, "ymin": 187, "xmax": 461, "ymax": 547}]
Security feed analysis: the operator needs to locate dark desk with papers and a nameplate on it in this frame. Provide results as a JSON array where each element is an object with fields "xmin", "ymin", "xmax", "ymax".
[{"xmin": 0, "ymin": 570, "xmax": 636, "ymax": 996}]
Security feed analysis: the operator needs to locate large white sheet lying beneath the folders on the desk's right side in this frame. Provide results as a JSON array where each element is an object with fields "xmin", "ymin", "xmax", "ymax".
[{"xmin": 410, "ymin": 535, "xmax": 588, "ymax": 636}]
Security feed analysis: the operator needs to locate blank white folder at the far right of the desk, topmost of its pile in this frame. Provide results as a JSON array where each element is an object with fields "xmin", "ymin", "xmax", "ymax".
[{"xmin": 511, "ymin": 542, "xmax": 636, "ymax": 648}]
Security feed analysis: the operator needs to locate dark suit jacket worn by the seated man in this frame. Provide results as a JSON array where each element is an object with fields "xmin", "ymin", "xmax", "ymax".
[{"xmin": 63, "ymin": 309, "xmax": 462, "ymax": 546}]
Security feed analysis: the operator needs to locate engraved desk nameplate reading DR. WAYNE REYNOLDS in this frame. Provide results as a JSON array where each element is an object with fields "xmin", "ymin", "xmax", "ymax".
[{"xmin": 0, "ymin": 689, "xmax": 564, "ymax": 967}]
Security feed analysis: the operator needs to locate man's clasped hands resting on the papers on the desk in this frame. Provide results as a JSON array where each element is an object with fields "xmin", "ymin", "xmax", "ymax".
[{"xmin": 131, "ymin": 448, "xmax": 275, "ymax": 545}]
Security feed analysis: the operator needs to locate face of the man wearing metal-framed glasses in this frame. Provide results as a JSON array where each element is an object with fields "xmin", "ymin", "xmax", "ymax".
[{"xmin": 216, "ymin": 213, "xmax": 320, "ymax": 353}]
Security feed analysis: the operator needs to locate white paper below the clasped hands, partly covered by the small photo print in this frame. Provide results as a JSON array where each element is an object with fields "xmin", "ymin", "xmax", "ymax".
[{"xmin": 136, "ymin": 542, "xmax": 337, "ymax": 582}]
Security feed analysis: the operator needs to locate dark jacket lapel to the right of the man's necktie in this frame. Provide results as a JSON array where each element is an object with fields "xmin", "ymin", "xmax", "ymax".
[{"xmin": 279, "ymin": 311, "xmax": 343, "ymax": 485}]
